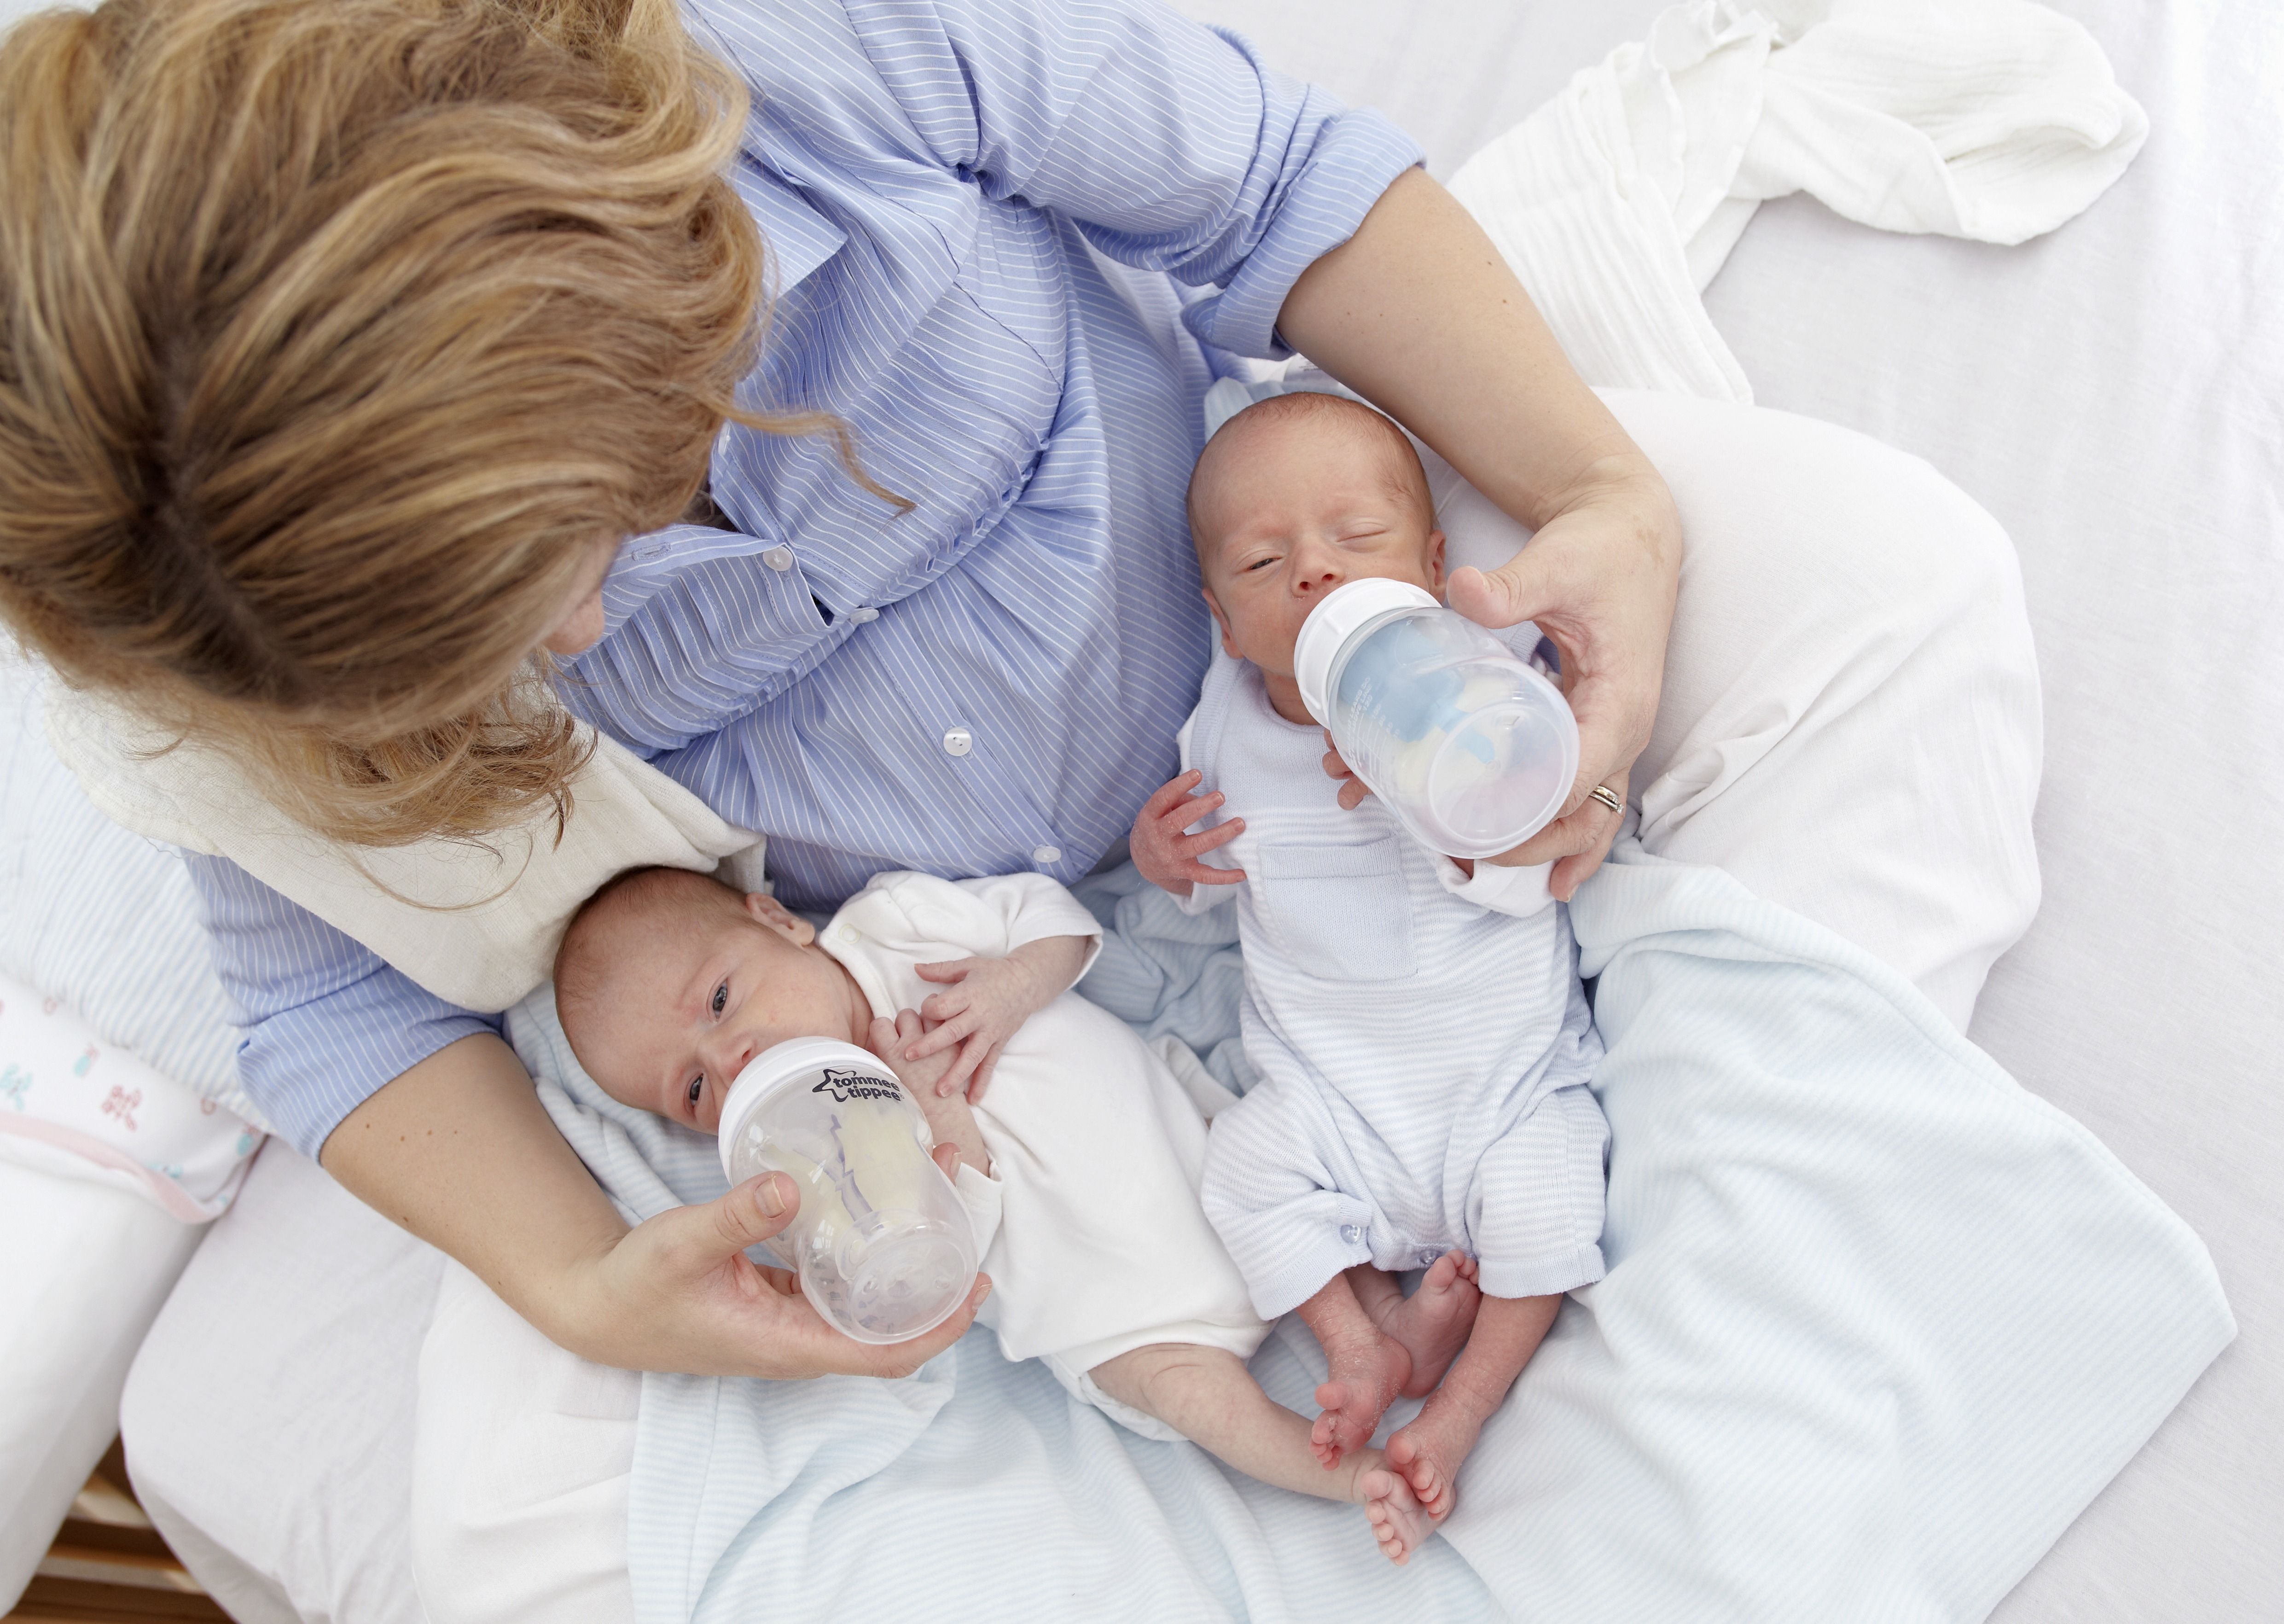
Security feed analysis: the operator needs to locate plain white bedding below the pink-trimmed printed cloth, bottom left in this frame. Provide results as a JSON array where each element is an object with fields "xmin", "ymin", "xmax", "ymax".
[{"xmin": 0, "ymin": 1163, "xmax": 205, "ymax": 1610}]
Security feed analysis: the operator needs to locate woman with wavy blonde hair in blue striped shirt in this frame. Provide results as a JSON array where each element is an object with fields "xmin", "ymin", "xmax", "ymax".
[{"xmin": 0, "ymin": 0, "xmax": 1679, "ymax": 1377}]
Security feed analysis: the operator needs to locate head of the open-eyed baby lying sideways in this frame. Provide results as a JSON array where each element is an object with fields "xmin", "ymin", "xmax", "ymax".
[{"xmin": 555, "ymin": 868, "xmax": 870, "ymax": 1133}]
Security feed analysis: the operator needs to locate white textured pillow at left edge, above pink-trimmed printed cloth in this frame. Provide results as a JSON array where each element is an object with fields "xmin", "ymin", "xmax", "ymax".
[{"xmin": 0, "ymin": 644, "xmax": 267, "ymax": 1131}]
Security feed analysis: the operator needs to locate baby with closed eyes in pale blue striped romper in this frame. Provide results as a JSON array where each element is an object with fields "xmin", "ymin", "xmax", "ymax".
[{"xmin": 1133, "ymin": 395, "xmax": 1608, "ymax": 1521}]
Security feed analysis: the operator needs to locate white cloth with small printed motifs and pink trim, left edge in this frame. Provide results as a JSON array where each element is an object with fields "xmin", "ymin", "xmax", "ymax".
[{"xmin": 0, "ymin": 975, "xmax": 263, "ymax": 1224}]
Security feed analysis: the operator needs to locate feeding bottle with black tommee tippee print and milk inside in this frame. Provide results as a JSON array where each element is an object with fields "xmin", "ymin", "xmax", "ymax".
[{"xmin": 720, "ymin": 1037, "xmax": 975, "ymax": 1343}]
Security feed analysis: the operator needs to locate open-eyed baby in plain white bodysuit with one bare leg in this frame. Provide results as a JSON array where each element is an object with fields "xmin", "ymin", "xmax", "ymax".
[{"xmin": 555, "ymin": 868, "xmax": 1432, "ymax": 1562}]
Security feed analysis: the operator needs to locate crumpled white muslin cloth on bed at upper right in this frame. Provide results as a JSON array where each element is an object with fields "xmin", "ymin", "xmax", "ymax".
[{"xmin": 1450, "ymin": 0, "xmax": 2149, "ymax": 400}]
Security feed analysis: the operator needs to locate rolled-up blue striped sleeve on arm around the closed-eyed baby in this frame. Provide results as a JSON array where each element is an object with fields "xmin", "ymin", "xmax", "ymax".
[{"xmin": 849, "ymin": 0, "xmax": 1421, "ymax": 359}]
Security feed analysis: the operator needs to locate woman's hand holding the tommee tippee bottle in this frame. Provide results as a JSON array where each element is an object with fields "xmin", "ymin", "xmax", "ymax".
[{"xmin": 566, "ymin": 1172, "xmax": 991, "ymax": 1380}]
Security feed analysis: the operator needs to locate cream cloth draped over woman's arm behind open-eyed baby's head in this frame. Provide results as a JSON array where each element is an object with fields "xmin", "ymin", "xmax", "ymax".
[{"xmin": 48, "ymin": 685, "xmax": 761, "ymax": 1014}]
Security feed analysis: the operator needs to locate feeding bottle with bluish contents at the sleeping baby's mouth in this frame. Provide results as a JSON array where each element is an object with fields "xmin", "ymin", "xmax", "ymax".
[{"xmin": 1293, "ymin": 580, "xmax": 1578, "ymax": 856}]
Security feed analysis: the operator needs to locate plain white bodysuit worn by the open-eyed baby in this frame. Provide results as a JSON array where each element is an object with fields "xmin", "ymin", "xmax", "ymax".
[{"xmin": 818, "ymin": 875, "xmax": 1267, "ymax": 1437}]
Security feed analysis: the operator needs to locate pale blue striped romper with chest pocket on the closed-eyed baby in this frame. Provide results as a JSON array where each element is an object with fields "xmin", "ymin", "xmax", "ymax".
[{"xmin": 1181, "ymin": 656, "xmax": 1610, "ymax": 1318}]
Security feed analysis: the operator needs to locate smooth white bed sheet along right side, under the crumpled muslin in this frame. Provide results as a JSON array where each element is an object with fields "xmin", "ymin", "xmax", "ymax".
[{"xmin": 1179, "ymin": 0, "xmax": 2284, "ymax": 1624}]
